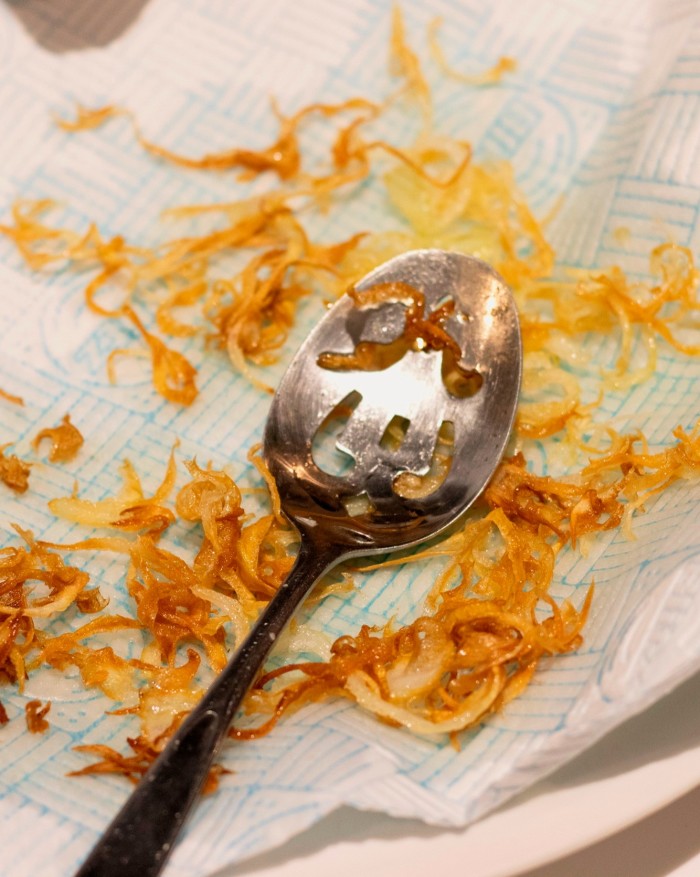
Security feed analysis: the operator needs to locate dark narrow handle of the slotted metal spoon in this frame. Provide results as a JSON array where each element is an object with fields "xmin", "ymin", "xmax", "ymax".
[{"xmin": 75, "ymin": 536, "xmax": 341, "ymax": 877}]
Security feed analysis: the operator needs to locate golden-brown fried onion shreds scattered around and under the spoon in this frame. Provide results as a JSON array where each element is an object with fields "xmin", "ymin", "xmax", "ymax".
[{"xmin": 0, "ymin": 10, "xmax": 700, "ymax": 788}]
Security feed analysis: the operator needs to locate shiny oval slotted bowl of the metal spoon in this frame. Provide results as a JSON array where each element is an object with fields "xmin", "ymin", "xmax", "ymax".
[{"xmin": 263, "ymin": 250, "xmax": 522, "ymax": 553}]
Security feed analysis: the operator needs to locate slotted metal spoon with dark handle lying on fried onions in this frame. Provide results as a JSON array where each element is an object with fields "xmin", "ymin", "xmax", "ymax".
[{"xmin": 76, "ymin": 250, "xmax": 522, "ymax": 877}]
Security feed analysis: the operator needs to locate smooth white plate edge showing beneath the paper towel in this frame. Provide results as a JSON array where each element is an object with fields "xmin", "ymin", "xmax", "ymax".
[{"xmin": 217, "ymin": 674, "xmax": 700, "ymax": 877}]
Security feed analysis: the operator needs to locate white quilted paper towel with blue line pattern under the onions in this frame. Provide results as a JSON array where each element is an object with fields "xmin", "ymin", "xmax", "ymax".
[{"xmin": 0, "ymin": 0, "xmax": 700, "ymax": 877}]
